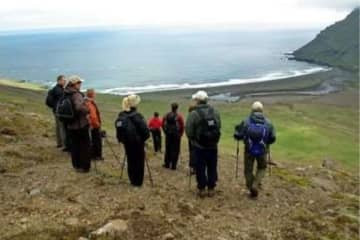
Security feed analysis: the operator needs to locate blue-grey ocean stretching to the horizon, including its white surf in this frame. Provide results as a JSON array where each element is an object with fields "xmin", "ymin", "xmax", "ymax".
[{"xmin": 0, "ymin": 29, "xmax": 326, "ymax": 94}]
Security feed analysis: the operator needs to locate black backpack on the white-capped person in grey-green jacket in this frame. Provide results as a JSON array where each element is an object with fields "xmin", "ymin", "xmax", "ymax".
[{"xmin": 196, "ymin": 107, "xmax": 221, "ymax": 148}]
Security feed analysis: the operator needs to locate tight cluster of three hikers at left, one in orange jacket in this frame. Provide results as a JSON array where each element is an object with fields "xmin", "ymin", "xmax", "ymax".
[{"xmin": 46, "ymin": 75, "xmax": 103, "ymax": 173}]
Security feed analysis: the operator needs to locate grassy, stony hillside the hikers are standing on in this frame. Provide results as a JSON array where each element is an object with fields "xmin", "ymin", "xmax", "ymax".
[{"xmin": 0, "ymin": 81, "xmax": 360, "ymax": 240}]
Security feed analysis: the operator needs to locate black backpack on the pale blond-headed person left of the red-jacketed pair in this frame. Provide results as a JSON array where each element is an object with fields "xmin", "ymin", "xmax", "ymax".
[{"xmin": 115, "ymin": 112, "xmax": 141, "ymax": 144}]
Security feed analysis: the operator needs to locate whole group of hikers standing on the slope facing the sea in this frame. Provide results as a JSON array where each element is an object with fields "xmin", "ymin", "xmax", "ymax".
[{"xmin": 46, "ymin": 75, "xmax": 276, "ymax": 198}]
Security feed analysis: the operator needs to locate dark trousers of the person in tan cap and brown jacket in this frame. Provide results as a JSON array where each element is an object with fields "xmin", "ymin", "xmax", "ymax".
[{"xmin": 69, "ymin": 127, "xmax": 91, "ymax": 171}]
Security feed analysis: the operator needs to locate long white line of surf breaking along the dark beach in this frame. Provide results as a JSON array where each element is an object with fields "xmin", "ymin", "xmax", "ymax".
[{"xmin": 101, "ymin": 67, "xmax": 331, "ymax": 95}]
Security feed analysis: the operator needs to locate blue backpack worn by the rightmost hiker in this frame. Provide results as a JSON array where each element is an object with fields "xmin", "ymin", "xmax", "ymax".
[{"xmin": 246, "ymin": 119, "xmax": 267, "ymax": 157}]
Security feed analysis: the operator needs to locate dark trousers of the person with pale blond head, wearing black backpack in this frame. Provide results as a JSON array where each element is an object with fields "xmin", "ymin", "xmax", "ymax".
[{"xmin": 125, "ymin": 143, "xmax": 145, "ymax": 186}]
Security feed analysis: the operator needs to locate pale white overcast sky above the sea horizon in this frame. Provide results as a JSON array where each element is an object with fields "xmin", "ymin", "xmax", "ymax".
[{"xmin": 0, "ymin": 0, "xmax": 359, "ymax": 31}]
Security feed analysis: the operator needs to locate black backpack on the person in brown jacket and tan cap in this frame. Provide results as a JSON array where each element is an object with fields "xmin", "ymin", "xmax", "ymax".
[{"xmin": 55, "ymin": 93, "xmax": 77, "ymax": 124}]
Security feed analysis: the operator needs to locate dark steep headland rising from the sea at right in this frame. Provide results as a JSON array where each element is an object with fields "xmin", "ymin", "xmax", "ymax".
[{"xmin": 293, "ymin": 8, "xmax": 359, "ymax": 71}]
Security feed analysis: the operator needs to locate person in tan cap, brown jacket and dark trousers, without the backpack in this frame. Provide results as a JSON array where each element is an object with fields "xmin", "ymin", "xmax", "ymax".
[{"xmin": 64, "ymin": 75, "xmax": 91, "ymax": 173}]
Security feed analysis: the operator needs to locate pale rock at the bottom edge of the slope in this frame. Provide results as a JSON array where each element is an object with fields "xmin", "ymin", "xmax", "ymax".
[{"xmin": 90, "ymin": 219, "xmax": 128, "ymax": 239}]
